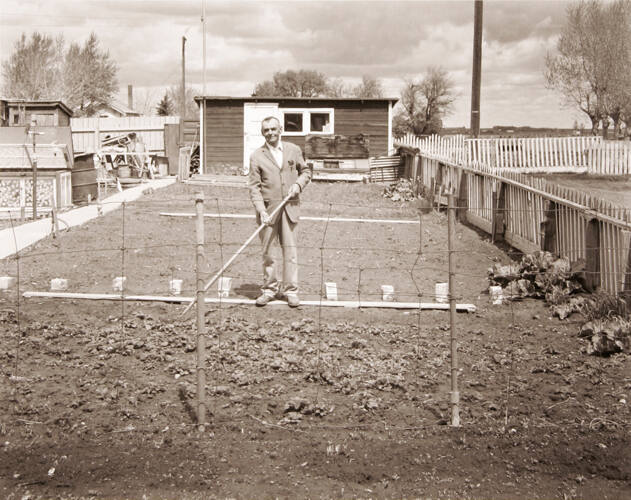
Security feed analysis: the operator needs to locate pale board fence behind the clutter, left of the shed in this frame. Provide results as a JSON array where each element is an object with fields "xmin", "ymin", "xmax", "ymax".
[{"xmin": 70, "ymin": 116, "xmax": 180, "ymax": 155}]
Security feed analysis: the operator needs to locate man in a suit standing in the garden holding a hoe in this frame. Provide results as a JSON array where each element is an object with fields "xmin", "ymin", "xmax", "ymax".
[{"xmin": 248, "ymin": 116, "xmax": 311, "ymax": 307}]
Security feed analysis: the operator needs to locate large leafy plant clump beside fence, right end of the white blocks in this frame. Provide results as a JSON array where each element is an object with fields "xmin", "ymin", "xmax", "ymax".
[{"xmin": 488, "ymin": 251, "xmax": 584, "ymax": 304}]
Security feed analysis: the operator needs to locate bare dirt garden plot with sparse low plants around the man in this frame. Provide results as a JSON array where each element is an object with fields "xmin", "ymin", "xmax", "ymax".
[{"xmin": 0, "ymin": 184, "xmax": 631, "ymax": 499}]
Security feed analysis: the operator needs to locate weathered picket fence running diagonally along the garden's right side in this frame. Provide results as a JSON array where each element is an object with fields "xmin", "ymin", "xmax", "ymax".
[{"xmin": 401, "ymin": 136, "xmax": 631, "ymax": 297}]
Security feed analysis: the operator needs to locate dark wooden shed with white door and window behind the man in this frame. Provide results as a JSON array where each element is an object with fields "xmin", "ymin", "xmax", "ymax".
[{"xmin": 195, "ymin": 96, "xmax": 397, "ymax": 174}]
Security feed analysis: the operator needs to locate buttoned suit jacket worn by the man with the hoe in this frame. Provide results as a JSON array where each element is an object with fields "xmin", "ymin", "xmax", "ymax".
[{"xmin": 248, "ymin": 142, "xmax": 311, "ymax": 222}]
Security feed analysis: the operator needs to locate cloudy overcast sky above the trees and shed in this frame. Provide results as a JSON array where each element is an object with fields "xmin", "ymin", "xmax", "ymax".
[{"xmin": 0, "ymin": 0, "xmax": 585, "ymax": 127}]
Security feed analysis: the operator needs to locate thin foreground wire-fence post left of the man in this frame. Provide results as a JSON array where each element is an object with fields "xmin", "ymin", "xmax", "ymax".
[{"xmin": 195, "ymin": 191, "xmax": 206, "ymax": 431}]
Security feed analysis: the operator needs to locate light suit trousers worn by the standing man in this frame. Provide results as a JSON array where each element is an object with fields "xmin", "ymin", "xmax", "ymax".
[{"xmin": 259, "ymin": 210, "xmax": 298, "ymax": 295}]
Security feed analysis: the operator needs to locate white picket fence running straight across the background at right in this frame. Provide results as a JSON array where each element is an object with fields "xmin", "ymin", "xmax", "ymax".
[{"xmin": 395, "ymin": 134, "xmax": 631, "ymax": 175}]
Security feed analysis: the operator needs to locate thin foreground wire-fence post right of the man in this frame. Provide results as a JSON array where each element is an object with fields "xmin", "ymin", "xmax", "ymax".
[{"xmin": 447, "ymin": 194, "xmax": 460, "ymax": 427}]
